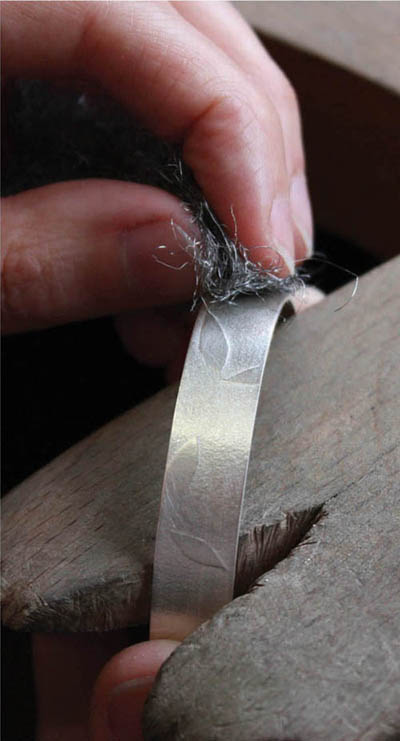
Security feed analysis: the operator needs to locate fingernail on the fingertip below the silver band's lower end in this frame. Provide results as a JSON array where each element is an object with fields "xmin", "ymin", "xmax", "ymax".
[{"xmin": 108, "ymin": 675, "xmax": 154, "ymax": 741}]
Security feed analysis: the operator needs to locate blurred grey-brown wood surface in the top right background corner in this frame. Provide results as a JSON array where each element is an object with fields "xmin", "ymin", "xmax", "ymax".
[{"xmin": 238, "ymin": 0, "xmax": 400, "ymax": 93}]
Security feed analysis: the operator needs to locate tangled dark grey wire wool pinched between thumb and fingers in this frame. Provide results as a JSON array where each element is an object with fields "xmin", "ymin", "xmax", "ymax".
[{"xmin": 3, "ymin": 80, "xmax": 303, "ymax": 304}]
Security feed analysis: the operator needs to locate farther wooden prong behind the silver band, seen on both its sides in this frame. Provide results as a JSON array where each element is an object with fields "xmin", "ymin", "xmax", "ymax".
[{"xmin": 2, "ymin": 258, "xmax": 400, "ymax": 646}]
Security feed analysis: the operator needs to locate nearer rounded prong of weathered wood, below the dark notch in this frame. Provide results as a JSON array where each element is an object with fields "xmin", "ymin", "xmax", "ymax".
[{"xmin": 145, "ymin": 472, "xmax": 400, "ymax": 741}]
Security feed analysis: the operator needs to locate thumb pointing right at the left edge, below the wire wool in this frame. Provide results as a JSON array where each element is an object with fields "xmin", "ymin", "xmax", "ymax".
[{"xmin": 2, "ymin": 180, "xmax": 198, "ymax": 332}]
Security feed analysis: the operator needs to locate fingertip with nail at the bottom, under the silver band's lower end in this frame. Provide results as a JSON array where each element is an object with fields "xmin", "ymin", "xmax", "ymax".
[{"xmin": 90, "ymin": 641, "xmax": 179, "ymax": 741}]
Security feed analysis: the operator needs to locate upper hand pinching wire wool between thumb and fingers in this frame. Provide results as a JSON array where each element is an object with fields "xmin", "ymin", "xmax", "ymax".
[{"xmin": 3, "ymin": 2, "xmax": 312, "ymax": 346}]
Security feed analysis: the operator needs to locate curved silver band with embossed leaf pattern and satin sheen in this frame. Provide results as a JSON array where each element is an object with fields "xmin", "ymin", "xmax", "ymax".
[{"xmin": 150, "ymin": 293, "xmax": 293, "ymax": 640}]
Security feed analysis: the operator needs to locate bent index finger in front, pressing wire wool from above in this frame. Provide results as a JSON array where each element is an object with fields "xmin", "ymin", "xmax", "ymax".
[{"xmin": 3, "ymin": 2, "xmax": 294, "ymax": 269}]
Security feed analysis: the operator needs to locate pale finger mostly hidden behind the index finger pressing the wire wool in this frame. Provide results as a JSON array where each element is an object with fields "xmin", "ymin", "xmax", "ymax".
[{"xmin": 172, "ymin": 2, "xmax": 313, "ymax": 259}]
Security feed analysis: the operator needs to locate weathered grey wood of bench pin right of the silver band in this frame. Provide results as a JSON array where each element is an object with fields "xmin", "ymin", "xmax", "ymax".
[{"xmin": 144, "ymin": 260, "xmax": 400, "ymax": 741}]
